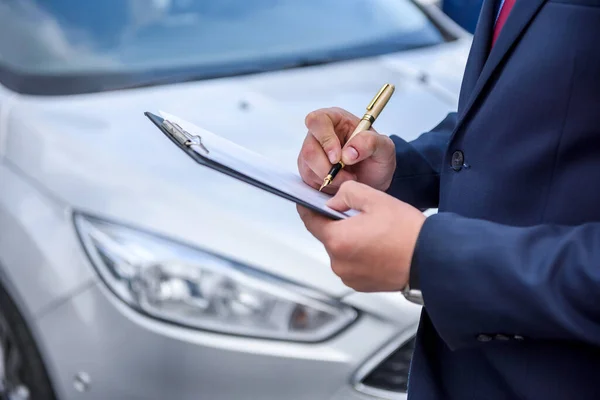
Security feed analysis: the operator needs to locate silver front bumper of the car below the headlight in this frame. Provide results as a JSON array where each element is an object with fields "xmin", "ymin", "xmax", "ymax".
[{"xmin": 38, "ymin": 283, "xmax": 415, "ymax": 400}]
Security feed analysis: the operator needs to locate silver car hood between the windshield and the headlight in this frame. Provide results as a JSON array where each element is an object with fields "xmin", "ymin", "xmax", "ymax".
[{"xmin": 5, "ymin": 42, "xmax": 468, "ymax": 296}]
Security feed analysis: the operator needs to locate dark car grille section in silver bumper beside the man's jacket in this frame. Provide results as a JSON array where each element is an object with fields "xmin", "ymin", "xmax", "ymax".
[{"xmin": 361, "ymin": 338, "xmax": 415, "ymax": 393}]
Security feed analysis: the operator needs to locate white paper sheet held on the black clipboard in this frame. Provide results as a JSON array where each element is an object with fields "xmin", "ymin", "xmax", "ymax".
[{"xmin": 159, "ymin": 111, "xmax": 358, "ymax": 219}]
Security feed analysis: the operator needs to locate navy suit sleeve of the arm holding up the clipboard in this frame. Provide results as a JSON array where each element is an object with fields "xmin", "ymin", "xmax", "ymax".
[{"xmin": 413, "ymin": 213, "xmax": 600, "ymax": 349}]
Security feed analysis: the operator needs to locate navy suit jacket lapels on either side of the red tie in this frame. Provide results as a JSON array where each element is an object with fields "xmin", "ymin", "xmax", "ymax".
[{"xmin": 454, "ymin": 0, "xmax": 547, "ymax": 133}]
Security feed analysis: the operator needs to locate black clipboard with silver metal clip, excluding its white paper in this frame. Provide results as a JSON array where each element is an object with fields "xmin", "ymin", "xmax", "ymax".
[{"xmin": 144, "ymin": 112, "xmax": 355, "ymax": 220}]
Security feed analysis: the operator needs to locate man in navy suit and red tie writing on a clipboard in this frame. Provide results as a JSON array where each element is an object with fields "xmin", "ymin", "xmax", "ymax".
[{"xmin": 298, "ymin": 0, "xmax": 600, "ymax": 400}]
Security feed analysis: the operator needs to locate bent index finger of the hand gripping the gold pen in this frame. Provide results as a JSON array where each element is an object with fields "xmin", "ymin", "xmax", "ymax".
[{"xmin": 304, "ymin": 109, "xmax": 342, "ymax": 164}]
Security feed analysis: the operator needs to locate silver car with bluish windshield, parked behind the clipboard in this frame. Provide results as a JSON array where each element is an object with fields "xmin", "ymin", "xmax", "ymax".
[{"xmin": 0, "ymin": 0, "xmax": 471, "ymax": 400}]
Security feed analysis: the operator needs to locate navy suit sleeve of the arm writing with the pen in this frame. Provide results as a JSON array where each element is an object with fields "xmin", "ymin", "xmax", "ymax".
[{"xmin": 387, "ymin": 113, "xmax": 456, "ymax": 209}]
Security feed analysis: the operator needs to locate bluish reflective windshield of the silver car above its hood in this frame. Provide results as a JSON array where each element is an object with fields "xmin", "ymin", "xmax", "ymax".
[{"xmin": 0, "ymin": 0, "xmax": 444, "ymax": 94}]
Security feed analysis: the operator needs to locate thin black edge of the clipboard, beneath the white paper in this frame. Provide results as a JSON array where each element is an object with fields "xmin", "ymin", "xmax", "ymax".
[{"xmin": 144, "ymin": 111, "xmax": 342, "ymax": 221}]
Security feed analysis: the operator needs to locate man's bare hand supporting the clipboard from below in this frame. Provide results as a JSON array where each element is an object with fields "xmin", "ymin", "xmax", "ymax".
[{"xmin": 298, "ymin": 181, "xmax": 426, "ymax": 292}]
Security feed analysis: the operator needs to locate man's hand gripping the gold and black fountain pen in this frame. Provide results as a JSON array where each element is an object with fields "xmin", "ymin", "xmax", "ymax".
[{"xmin": 298, "ymin": 108, "xmax": 396, "ymax": 194}]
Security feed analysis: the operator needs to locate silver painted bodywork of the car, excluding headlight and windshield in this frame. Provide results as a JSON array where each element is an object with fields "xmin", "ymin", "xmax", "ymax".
[{"xmin": 0, "ymin": 36, "xmax": 469, "ymax": 400}]
